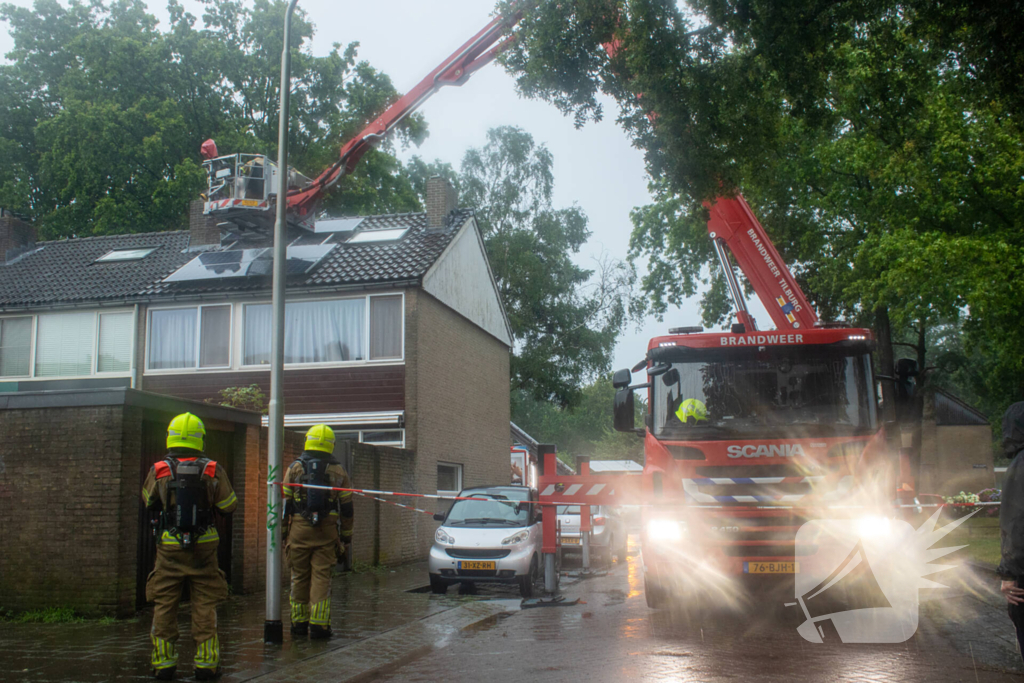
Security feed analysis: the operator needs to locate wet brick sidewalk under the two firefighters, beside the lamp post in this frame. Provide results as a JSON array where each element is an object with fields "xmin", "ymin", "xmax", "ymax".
[{"xmin": 0, "ymin": 563, "xmax": 519, "ymax": 683}]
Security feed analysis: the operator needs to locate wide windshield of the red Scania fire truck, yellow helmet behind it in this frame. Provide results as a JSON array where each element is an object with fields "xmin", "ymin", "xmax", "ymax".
[{"xmin": 651, "ymin": 347, "xmax": 878, "ymax": 440}]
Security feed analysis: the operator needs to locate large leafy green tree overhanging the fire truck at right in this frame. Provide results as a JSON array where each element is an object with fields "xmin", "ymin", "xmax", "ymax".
[{"xmin": 504, "ymin": 0, "xmax": 1024, "ymax": 419}]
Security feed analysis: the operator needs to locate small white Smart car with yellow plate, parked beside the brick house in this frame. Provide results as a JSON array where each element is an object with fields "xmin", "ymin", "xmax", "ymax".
[{"xmin": 428, "ymin": 485, "xmax": 542, "ymax": 598}]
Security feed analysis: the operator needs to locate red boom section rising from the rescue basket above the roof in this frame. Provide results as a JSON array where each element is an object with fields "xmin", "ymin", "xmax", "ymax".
[{"xmin": 287, "ymin": 12, "xmax": 522, "ymax": 217}]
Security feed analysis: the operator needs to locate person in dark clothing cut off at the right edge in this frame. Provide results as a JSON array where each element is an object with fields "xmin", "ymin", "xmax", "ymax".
[{"xmin": 997, "ymin": 401, "xmax": 1024, "ymax": 657}]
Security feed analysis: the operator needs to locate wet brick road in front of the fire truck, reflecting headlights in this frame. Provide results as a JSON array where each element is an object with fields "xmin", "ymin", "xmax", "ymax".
[{"xmin": 380, "ymin": 544, "xmax": 1024, "ymax": 683}]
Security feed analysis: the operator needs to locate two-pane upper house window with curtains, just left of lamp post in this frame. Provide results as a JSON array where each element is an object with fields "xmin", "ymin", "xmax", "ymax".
[{"xmin": 148, "ymin": 304, "xmax": 231, "ymax": 370}]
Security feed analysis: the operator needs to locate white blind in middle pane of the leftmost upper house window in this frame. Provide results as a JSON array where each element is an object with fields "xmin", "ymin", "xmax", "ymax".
[{"xmin": 36, "ymin": 312, "xmax": 96, "ymax": 377}]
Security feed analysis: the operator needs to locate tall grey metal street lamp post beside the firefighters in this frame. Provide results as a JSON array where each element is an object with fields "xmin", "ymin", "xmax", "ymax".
[{"xmin": 263, "ymin": 0, "xmax": 298, "ymax": 643}]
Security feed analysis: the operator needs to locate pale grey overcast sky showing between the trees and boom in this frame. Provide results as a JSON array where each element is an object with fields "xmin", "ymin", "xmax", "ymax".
[{"xmin": 0, "ymin": 0, "xmax": 770, "ymax": 369}]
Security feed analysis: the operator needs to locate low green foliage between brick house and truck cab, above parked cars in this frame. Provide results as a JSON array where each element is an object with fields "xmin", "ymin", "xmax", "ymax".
[{"xmin": 512, "ymin": 375, "xmax": 647, "ymax": 467}]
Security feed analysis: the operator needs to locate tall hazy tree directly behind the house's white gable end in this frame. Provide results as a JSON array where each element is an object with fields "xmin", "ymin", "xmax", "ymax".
[{"xmin": 411, "ymin": 126, "xmax": 634, "ymax": 407}]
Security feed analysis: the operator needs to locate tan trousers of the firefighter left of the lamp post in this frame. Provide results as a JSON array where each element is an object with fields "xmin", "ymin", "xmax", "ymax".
[{"xmin": 145, "ymin": 543, "xmax": 227, "ymax": 669}]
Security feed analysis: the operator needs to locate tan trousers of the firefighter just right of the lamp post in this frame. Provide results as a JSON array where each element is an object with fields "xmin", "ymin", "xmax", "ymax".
[{"xmin": 285, "ymin": 529, "xmax": 337, "ymax": 627}]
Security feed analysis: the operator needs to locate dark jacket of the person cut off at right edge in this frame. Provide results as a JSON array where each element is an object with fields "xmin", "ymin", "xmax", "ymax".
[{"xmin": 998, "ymin": 401, "xmax": 1024, "ymax": 579}]
